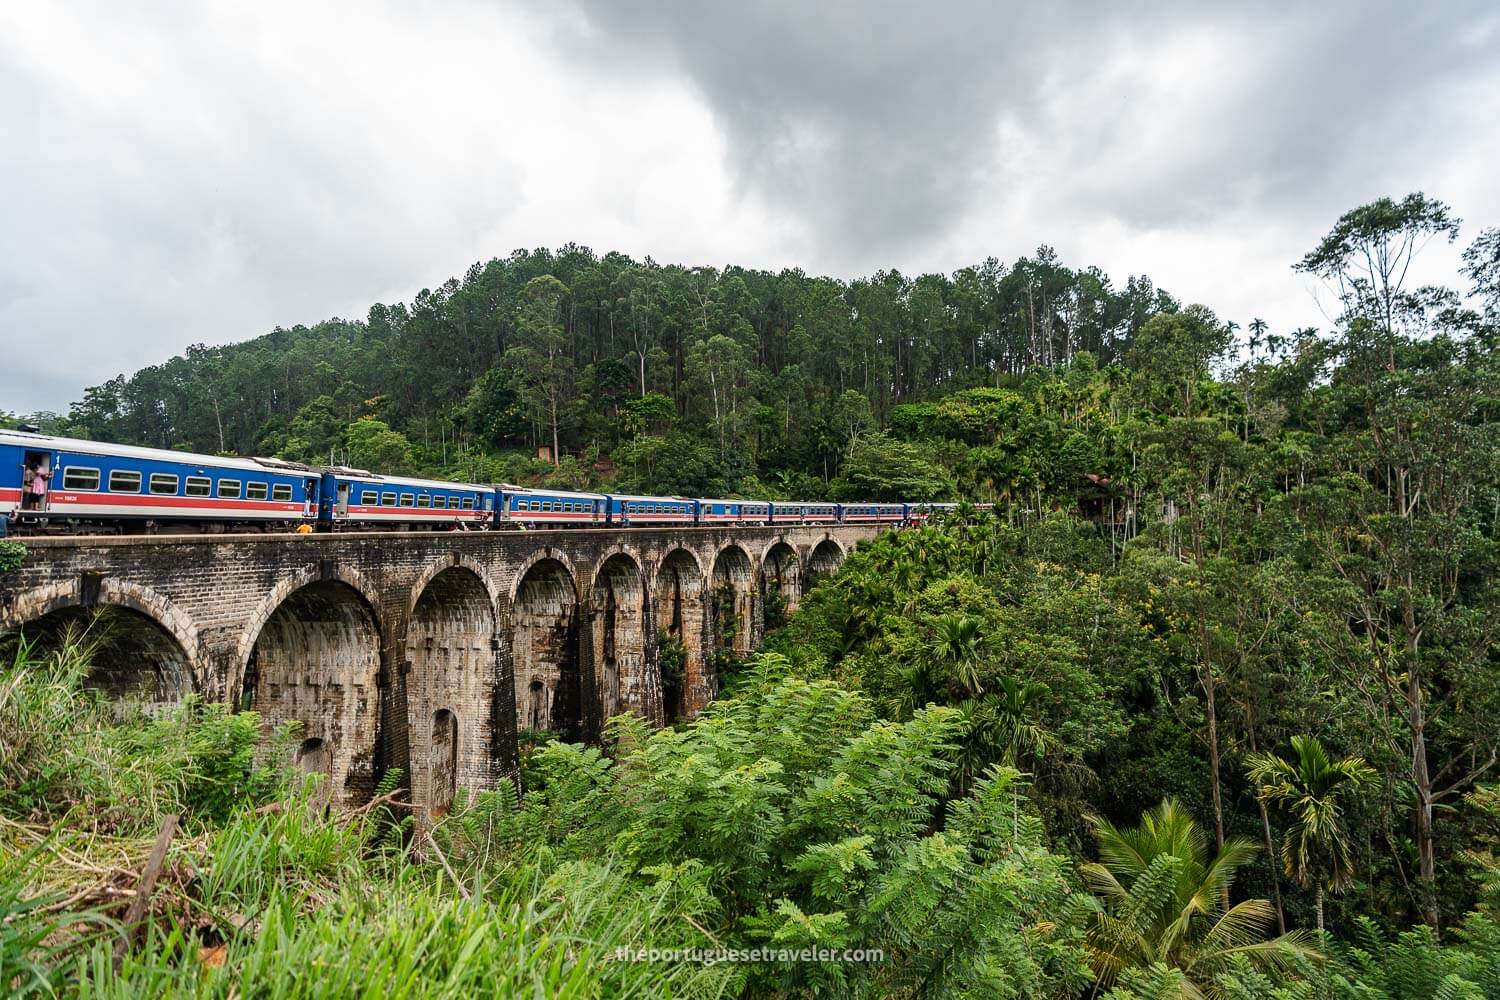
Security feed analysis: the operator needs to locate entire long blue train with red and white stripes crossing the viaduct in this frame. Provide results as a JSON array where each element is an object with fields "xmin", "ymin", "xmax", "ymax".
[{"xmin": 0, "ymin": 430, "xmax": 957, "ymax": 535}]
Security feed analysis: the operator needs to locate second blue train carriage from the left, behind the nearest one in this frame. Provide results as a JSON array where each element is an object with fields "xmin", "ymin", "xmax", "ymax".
[{"xmin": 328, "ymin": 466, "xmax": 495, "ymax": 531}]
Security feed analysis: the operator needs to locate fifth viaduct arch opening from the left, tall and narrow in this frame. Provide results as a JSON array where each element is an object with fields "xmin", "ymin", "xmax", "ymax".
[{"xmin": 591, "ymin": 552, "xmax": 662, "ymax": 721}]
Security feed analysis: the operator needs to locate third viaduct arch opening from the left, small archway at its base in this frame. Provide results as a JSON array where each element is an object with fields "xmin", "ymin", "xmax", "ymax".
[{"xmin": 405, "ymin": 567, "xmax": 500, "ymax": 810}]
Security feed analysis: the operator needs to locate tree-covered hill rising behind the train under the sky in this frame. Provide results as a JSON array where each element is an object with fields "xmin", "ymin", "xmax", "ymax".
[{"xmin": 17, "ymin": 238, "xmax": 1178, "ymax": 498}]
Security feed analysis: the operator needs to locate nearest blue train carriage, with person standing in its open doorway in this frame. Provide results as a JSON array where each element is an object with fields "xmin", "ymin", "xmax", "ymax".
[{"xmin": 0, "ymin": 430, "xmax": 320, "ymax": 531}]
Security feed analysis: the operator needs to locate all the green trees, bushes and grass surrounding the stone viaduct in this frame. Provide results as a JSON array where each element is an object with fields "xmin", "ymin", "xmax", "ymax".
[{"xmin": 0, "ymin": 195, "xmax": 1500, "ymax": 1000}]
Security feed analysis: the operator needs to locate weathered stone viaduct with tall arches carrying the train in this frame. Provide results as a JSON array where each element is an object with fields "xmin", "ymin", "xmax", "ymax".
[{"xmin": 0, "ymin": 525, "xmax": 881, "ymax": 814}]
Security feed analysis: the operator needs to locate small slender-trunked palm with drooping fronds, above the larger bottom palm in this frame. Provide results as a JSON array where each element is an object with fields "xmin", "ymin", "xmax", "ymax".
[{"xmin": 1248, "ymin": 736, "xmax": 1376, "ymax": 934}]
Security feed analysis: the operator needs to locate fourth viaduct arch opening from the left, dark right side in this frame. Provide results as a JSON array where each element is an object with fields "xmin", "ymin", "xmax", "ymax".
[{"xmin": 512, "ymin": 559, "xmax": 585, "ymax": 741}]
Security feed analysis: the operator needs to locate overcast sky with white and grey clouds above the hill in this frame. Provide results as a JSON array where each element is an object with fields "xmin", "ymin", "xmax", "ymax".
[{"xmin": 0, "ymin": 0, "xmax": 1500, "ymax": 411}]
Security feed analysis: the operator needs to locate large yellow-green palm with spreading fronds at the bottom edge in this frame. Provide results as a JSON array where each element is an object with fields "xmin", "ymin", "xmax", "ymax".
[{"xmin": 1083, "ymin": 799, "xmax": 1319, "ymax": 1000}]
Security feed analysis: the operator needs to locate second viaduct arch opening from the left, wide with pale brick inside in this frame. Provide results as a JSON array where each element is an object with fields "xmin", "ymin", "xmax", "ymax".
[{"xmin": 240, "ymin": 582, "xmax": 381, "ymax": 802}]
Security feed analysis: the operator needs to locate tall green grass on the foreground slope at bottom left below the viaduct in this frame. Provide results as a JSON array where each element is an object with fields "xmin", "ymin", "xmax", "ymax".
[{"xmin": 0, "ymin": 636, "xmax": 740, "ymax": 1000}]
